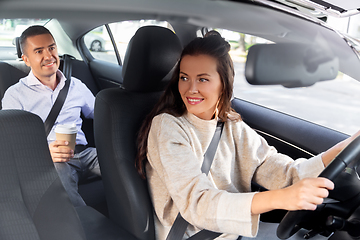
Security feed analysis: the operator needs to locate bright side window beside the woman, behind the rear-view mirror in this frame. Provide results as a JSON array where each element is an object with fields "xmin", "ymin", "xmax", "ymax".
[{"xmin": 217, "ymin": 29, "xmax": 360, "ymax": 134}]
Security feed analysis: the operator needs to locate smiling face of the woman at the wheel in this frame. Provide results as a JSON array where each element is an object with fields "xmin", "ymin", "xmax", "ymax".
[{"xmin": 179, "ymin": 55, "xmax": 222, "ymax": 120}]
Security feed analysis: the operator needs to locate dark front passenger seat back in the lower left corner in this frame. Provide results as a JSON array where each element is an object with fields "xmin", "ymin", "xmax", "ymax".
[{"xmin": 0, "ymin": 110, "xmax": 135, "ymax": 240}]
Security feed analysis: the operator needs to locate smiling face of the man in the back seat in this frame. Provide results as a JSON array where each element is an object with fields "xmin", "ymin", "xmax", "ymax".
[{"xmin": 22, "ymin": 34, "xmax": 60, "ymax": 81}]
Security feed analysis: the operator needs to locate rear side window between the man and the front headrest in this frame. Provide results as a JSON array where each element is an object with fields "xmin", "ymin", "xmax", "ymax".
[{"xmin": 84, "ymin": 20, "xmax": 171, "ymax": 64}]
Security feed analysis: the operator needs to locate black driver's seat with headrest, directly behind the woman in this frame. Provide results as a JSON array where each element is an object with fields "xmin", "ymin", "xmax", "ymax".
[{"xmin": 94, "ymin": 26, "xmax": 182, "ymax": 240}]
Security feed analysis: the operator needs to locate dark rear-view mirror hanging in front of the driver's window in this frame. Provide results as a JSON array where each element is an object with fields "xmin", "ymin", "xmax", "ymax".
[{"xmin": 245, "ymin": 43, "xmax": 339, "ymax": 87}]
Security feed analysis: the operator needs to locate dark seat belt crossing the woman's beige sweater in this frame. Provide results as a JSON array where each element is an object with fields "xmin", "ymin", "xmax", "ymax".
[{"xmin": 166, "ymin": 121, "xmax": 224, "ymax": 240}]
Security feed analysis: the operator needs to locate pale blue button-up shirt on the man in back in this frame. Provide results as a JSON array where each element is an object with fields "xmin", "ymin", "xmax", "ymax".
[{"xmin": 2, "ymin": 70, "xmax": 95, "ymax": 145}]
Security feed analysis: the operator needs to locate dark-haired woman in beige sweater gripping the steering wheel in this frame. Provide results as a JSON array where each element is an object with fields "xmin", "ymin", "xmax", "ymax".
[{"xmin": 136, "ymin": 31, "xmax": 355, "ymax": 240}]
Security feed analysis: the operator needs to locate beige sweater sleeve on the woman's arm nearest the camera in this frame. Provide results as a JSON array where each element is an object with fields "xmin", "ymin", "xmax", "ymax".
[{"xmin": 148, "ymin": 115, "xmax": 258, "ymax": 237}]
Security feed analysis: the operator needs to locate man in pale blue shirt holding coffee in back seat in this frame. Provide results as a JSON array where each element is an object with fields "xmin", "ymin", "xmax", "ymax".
[{"xmin": 2, "ymin": 26, "xmax": 100, "ymax": 206}]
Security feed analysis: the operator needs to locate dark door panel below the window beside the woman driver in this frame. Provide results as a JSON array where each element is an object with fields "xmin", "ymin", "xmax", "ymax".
[{"xmin": 232, "ymin": 98, "xmax": 348, "ymax": 158}]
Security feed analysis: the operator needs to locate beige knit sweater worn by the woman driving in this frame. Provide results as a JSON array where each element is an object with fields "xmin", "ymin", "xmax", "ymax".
[{"xmin": 146, "ymin": 113, "xmax": 324, "ymax": 240}]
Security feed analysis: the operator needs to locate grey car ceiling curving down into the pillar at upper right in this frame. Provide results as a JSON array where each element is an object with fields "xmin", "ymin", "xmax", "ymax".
[{"xmin": 0, "ymin": 0, "xmax": 360, "ymax": 79}]
